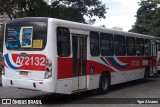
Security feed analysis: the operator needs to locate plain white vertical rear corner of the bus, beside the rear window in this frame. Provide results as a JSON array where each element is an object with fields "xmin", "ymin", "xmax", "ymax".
[{"xmin": 45, "ymin": 18, "xmax": 58, "ymax": 92}]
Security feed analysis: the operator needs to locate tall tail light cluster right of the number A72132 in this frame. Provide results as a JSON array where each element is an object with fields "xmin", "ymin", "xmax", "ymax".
[{"xmin": 44, "ymin": 58, "xmax": 52, "ymax": 79}]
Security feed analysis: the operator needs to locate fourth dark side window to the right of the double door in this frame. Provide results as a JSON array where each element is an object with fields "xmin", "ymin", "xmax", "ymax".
[{"xmin": 126, "ymin": 37, "xmax": 136, "ymax": 56}]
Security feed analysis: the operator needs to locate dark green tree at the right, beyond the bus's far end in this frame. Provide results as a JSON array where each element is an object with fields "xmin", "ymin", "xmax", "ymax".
[{"xmin": 130, "ymin": 0, "xmax": 160, "ymax": 36}]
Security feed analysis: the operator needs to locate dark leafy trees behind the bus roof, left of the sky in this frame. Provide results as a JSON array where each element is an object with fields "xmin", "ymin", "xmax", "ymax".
[{"xmin": 0, "ymin": 0, "xmax": 107, "ymax": 24}]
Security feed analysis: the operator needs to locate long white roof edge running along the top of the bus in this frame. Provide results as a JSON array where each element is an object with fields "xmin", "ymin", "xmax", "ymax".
[{"xmin": 7, "ymin": 17, "xmax": 160, "ymax": 39}]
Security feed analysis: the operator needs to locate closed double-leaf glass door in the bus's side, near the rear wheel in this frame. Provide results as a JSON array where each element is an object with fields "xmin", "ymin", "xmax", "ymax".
[{"xmin": 72, "ymin": 35, "xmax": 87, "ymax": 92}]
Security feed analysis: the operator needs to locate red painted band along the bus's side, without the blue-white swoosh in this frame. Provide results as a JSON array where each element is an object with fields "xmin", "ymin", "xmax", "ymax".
[{"xmin": 58, "ymin": 56, "xmax": 156, "ymax": 79}]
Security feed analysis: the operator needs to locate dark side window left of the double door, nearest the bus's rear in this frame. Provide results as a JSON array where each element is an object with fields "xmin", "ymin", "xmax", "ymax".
[{"xmin": 57, "ymin": 27, "xmax": 70, "ymax": 57}]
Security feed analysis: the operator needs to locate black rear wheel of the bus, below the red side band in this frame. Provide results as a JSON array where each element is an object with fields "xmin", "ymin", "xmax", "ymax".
[{"xmin": 97, "ymin": 73, "xmax": 110, "ymax": 94}]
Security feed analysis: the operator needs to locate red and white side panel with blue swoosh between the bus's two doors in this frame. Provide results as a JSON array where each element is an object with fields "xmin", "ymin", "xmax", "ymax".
[{"xmin": 87, "ymin": 56, "xmax": 151, "ymax": 87}]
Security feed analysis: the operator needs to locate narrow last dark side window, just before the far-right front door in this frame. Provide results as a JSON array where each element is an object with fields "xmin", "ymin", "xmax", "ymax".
[{"xmin": 144, "ymin": 39, "xmax": 151, "ymax": 56}]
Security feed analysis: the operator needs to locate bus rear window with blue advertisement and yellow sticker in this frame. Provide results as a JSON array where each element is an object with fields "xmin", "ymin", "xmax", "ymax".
[{"xmin": 5, "ymin": 21, "xmax": 47, "ymax": 51}]
